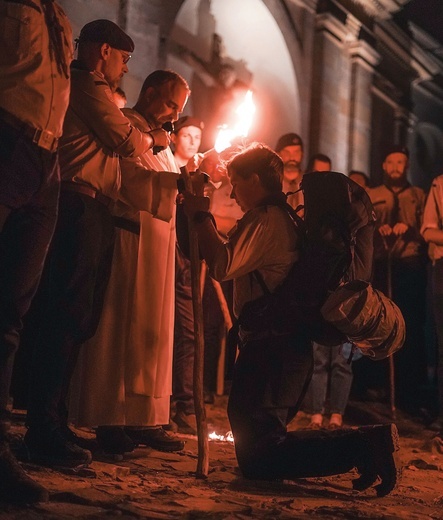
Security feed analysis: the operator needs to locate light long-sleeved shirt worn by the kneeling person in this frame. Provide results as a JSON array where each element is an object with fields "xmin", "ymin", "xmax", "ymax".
[{"xmin": 209, "ymin": 205, "xmax": 299, "ymax": 316}]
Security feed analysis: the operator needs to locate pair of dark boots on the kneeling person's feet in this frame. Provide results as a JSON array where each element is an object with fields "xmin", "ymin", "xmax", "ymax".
[{"xmin": 352, "ymin": 424, "xmax": 401, "ymax": 497}]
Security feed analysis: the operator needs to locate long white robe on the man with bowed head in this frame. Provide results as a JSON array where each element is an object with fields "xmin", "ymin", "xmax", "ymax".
[{"xmin": 70, "ymin": 110, "xmax": 179, "ymax": 427}]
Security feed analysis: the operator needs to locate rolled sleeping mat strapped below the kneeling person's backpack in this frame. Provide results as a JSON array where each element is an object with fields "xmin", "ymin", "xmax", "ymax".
[{"xmin": 321, "ymin": 280, "xmax": 406, "ymax": 361}]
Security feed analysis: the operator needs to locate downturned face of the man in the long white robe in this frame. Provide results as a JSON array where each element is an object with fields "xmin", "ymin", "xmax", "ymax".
[{"xmin": 146, "ymin": 81, "xmax": 189, "ymax": 126}]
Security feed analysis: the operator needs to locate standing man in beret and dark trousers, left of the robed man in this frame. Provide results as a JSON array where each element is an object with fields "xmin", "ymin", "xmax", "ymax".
[{"xmin": 25, "ymin": 20, "xmax": 169, "ymax": 467}]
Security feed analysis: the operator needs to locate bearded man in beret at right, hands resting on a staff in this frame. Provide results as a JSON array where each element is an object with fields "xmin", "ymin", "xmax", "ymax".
[{"xmin": 368, "ymin": 146, "xmax": 426, "ymax": 412}]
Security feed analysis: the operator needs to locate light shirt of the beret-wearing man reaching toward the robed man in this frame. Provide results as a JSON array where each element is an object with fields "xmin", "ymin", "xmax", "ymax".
[{"xmin": 60, "ymin": 62, "xmax": 152, "ymax": 200}]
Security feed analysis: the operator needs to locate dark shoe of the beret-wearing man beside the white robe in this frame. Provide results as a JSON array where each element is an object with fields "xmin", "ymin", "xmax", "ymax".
[{"xmin": 25, "ymin": 427, "xmax": 92, "ymax": 468}]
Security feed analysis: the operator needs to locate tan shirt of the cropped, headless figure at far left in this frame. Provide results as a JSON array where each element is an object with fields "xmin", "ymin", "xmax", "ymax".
[{"xmin": 0, "ymin": 0, "xmax": 73, "ymax": 137}]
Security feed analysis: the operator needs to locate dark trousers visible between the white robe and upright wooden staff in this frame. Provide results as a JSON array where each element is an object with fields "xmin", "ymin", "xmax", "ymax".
[{"xmin": 172, "ymin": 245, "xmax": 195, "ymax": 415}]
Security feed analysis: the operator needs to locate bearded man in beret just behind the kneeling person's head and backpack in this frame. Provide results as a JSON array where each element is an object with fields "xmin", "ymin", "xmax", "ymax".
[{"xmin": 275, "ymin": 133, "xmax": 303, "ymax": 209}]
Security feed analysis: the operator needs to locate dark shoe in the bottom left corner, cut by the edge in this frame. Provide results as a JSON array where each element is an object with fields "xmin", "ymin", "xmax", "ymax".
[{"xmin": 0, "ymin": 441, "xmax": 49, "ymax": 504}]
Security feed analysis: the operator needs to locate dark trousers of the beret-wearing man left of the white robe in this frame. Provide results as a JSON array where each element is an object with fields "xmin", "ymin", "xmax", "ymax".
[{"xmin": 27, "ymin": 192, "xmax": 115, "ymax": 429}]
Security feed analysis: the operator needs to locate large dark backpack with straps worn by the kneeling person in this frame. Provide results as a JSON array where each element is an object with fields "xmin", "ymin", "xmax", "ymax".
[{"xmin": 238, "ymin": 172, "xmax": 375, "ymax": 345}]
